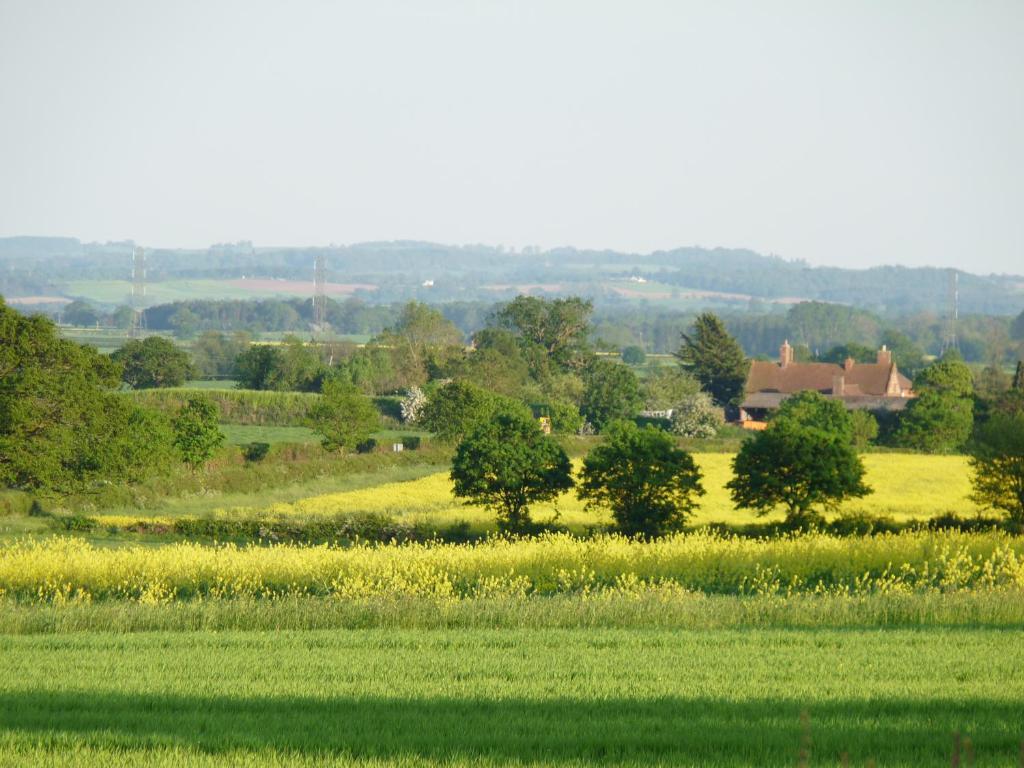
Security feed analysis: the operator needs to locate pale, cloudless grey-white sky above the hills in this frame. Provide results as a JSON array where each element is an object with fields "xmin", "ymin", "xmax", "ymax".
[{"xmin": 0, "ymin": 0, "xmax": 1024, "ymax": 273}]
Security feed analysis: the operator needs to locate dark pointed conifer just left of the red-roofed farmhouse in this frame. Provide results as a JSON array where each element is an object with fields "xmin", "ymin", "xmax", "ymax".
[{"xmin": 676, "ymin": 312, "xmax": 750, "ymax": 406}]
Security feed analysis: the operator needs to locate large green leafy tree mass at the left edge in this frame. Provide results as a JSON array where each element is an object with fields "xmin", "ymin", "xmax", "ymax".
[{"xmin": 0, "ymin": 301, "xmax": 171, "ymax": 493}]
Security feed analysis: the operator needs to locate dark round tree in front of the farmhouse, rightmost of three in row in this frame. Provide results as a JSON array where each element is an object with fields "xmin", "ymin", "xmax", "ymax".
[{"xmin": 726, "ymin": 421, "xmax": 871, "ymax": 524}]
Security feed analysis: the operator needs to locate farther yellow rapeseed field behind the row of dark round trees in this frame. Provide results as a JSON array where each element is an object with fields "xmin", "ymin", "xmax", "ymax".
[{"xmin": 199, "ymin": 454, "xmax": 978, "ymax": 530}]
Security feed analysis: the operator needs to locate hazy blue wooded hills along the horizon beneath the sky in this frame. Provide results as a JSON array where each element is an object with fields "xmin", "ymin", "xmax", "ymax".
[{"xmin": 0, "ymin": 237, "xmax": 1024, "ymax": 314}]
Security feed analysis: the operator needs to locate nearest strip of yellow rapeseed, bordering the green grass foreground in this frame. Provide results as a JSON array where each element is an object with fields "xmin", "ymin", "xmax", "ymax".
[{"xmin": 0, "ymin": 531, "xmax": 1024, "ymax": 602}]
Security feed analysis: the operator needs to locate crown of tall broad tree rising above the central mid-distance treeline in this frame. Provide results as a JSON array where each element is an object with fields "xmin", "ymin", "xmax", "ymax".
[{"xmin": 495, "ymin": 296, "xmax": 594, "ymax": 370}]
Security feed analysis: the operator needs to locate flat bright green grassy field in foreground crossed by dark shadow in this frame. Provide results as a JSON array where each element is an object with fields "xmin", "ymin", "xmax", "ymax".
[{"xmin": 0, "ymin": 629, "xmax": 1024, "ymax": 767}]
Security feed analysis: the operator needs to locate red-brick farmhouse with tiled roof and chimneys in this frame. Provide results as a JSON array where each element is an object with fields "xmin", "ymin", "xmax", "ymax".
[{"xmin": 739, "ymin": 341, "xmax": 914, "ymax": 429}]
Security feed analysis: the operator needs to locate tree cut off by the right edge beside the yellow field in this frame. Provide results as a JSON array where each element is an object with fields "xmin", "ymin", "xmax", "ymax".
[{"xmin": 970, "ymin": 413, "xmax": 1024, "ymax": 524}]
